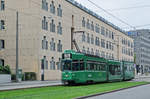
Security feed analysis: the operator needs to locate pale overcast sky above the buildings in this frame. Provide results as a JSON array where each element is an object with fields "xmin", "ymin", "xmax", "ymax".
[{"xmin": 76, "ymin": 0, "xmax": 150, "ymax": 30}]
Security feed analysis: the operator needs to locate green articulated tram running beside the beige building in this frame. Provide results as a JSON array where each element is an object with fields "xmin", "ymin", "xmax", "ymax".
[{"xmin": 61, "ymin": 50, "xmax": 134, "ymax": 85}]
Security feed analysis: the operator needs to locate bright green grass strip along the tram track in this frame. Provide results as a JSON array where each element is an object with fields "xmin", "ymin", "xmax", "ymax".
[{"xmin": 0, "ymin": 82, "xmax": 148, "ymax": 99}]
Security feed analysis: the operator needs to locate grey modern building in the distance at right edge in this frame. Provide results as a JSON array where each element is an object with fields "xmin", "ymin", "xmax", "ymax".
[{"xmin": 129, "ymin": 29, "xmax": 150, "ymax": 74}]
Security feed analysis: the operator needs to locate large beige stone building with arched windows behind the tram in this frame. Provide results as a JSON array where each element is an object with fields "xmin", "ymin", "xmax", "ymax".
[{"xmin": 0, "ymin": 0, "xmax": 134, "ymax": 80}]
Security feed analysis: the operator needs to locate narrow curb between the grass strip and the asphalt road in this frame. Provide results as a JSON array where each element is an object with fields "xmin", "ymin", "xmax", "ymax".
[{"xmin": 73, "ymin": 83, "xmax": 150, "ymax": 99}]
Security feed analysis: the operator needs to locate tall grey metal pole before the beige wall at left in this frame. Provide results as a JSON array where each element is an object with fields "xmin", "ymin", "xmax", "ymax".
[{"xmin": 16, "ymin": 11, "xmax": 19, "ymax": 82}]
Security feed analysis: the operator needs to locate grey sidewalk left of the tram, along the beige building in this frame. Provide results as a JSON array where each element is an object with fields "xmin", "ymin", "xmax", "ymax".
[{"xmin": 0, "ymin": 81, "xmax": 62, "ymax": 91}]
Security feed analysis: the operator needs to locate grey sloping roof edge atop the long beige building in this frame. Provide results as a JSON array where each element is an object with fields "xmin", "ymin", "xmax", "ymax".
[{"xmin": 66, "ymin": 0, "xmax": 128, "ymax": 36}]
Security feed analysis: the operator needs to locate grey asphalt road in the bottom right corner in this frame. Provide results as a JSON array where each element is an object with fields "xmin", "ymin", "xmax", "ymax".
[{"xmin": 87, "ymin": 85, "xmax": 150, "ymax": 99}]
